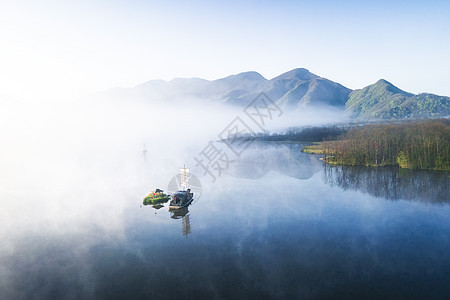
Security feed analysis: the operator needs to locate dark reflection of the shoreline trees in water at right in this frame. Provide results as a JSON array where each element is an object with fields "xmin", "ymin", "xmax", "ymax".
[{"xmin": 324, "ymin": 164, "xmax": 450, "ymax": 203}]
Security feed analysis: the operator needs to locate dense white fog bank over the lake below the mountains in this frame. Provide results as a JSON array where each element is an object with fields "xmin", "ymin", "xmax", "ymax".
[{"xmin": 0, "ymin": 95, "xmax": 342, "ymax": 229}]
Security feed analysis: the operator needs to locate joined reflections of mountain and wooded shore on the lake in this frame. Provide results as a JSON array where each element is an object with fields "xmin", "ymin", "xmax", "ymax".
[{"xmin": 226, "ymin": 142, "xmax": 450, "ymax": 203}]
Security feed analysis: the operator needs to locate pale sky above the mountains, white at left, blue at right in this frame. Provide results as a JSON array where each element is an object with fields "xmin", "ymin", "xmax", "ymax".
[{"xmin": 0, "ymin": 0, "xmax": 450, "ymax": 97}]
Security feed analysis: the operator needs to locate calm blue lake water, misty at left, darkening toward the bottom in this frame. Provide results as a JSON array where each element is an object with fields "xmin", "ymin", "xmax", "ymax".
[{"xmin": 0, "ymin": 144, "xmax": 450, "ymax": 299}]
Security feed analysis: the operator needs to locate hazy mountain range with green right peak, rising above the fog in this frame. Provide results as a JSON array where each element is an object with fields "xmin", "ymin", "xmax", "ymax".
[{"xmin": 110, "ymin": 68, "xmax": 450, "ymax": 119}]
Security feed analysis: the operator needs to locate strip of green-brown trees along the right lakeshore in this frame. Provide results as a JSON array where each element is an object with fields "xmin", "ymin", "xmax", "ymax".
[{"xmin": 302, "ymin": 119, "xmax": 450, "ymax": 171}]
